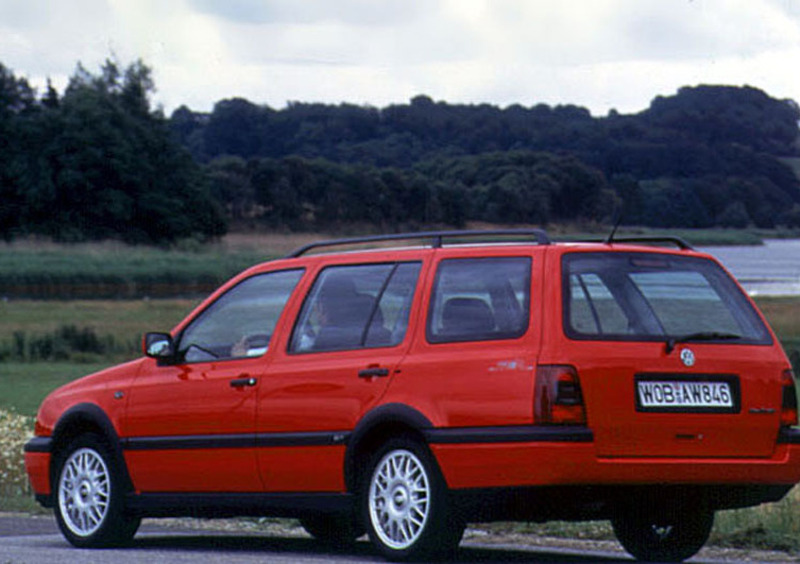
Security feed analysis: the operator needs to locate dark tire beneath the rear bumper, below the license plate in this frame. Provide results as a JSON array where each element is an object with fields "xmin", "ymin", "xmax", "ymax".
[{"xmin": 611, "ymin": 508, "xmax": 714, "ymax": 562}]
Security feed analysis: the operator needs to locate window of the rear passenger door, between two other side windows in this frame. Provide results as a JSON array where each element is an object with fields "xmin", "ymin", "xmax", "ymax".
[{"xmin": 289, "ymin": 262, "xmax": 421, "ymax": 353}]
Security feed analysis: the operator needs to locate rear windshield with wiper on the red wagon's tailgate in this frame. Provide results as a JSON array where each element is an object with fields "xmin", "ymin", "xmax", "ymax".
[{"xmin": 563, "ymin": 253, "xmax": 772, "ymax": 344}]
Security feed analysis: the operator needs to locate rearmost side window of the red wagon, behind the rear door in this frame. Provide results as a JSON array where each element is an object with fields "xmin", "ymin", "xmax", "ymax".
[{"xmin": 427, "ymin": 257, "xmax": 531, "ymax": 343}]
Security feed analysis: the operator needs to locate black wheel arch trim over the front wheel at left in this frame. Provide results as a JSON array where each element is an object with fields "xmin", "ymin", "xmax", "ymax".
[{"xmin": 50, "ymin": 403, "xmax": 133, "ymax": 495}]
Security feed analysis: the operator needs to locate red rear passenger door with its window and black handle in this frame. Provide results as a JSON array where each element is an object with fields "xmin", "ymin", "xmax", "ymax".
[{"xmin": 257, "ymin": 260, "xmax": 423, "ymax": 492}]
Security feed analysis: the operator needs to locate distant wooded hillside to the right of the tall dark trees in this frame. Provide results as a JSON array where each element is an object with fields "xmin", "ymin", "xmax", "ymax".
[{"xmin": 171, "ymin": 86, "xmax": 800, "ymax": 231}]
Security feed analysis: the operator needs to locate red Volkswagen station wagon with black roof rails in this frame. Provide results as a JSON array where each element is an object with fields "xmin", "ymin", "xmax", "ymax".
[{"xmin": 25, "ymin": 230, "xmax": 800, "ymax": 561}]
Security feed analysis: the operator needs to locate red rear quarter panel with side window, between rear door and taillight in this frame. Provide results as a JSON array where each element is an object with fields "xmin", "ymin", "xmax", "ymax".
[{"xmin": 392, "ymin": 247, "xmax": 542, "ymax": 428}]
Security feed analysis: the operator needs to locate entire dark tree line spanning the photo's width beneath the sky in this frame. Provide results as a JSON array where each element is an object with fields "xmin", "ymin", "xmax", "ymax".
[{"xmin": 0, "ymin": 61, "xmax": 800, "ymax": 243}]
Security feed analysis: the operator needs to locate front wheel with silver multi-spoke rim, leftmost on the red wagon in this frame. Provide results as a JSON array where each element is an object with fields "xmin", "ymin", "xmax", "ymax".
[{"xmin": 54, "ymin": 434, "xmax": 141, "ymax": 548}]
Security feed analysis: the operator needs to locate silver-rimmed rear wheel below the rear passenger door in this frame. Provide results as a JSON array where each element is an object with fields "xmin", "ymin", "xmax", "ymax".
[{"xmin": 360, "ymin": 438, "xmax": 464, "ymax": 561}]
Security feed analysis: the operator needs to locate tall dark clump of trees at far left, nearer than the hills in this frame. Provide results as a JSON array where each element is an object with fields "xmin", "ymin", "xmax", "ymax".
[{"xmin": 0, "ymin": 61, "xmax": 225, "ymax": 243}]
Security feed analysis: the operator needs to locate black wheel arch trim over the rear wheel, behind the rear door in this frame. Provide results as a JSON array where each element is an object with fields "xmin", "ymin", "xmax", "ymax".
[{"xmin": 344, "ymin": 403, "xmax": 433, "ymax": 492}]
